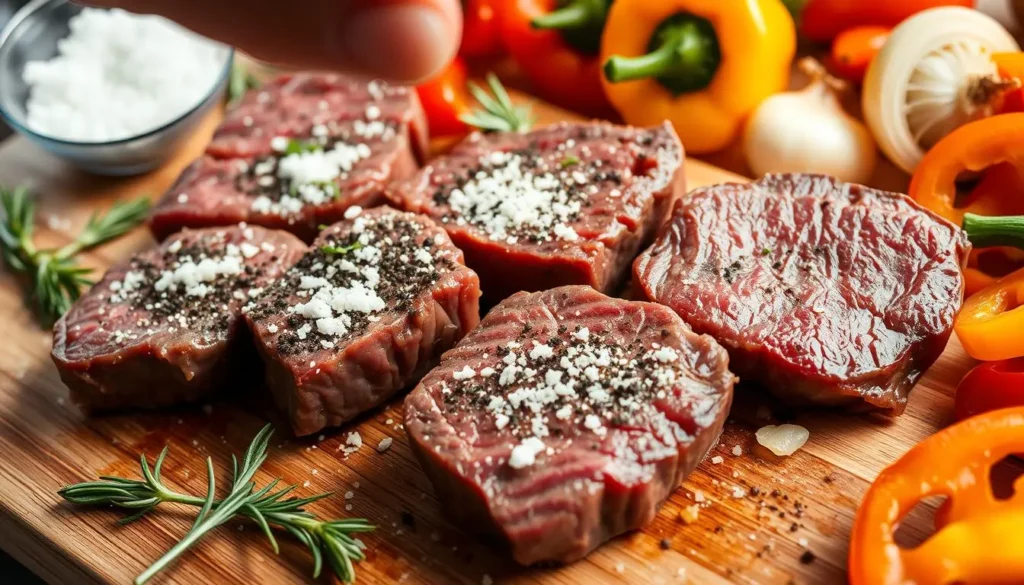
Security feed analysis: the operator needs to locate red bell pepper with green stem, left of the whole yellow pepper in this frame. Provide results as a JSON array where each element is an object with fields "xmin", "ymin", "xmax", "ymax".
[{"xmin": 502, "ymin": 0, "xmax": 611, "ymax": 117}]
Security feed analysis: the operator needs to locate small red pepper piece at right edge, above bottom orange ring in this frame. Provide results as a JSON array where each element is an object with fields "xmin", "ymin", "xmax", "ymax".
[{"xmin": 953, "ymin": 358, "xmax": 1024, "ymax": 420}]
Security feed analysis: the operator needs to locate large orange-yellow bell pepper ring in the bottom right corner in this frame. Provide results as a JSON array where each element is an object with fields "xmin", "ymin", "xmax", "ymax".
[{"xmin": 850, "ymin": 408, "xmax": 1024, "ymax": 585}]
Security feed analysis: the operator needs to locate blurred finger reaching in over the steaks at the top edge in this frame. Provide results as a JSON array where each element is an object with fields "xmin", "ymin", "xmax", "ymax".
[{"xmin": 84, "ymin": 0, "xmax": 462, "ymax": 82}]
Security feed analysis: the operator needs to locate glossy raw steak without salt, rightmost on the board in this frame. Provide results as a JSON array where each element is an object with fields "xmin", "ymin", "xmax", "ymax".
[{"xmin": 634, "ymin": 174, "xmax": 970, "ymax": 414}]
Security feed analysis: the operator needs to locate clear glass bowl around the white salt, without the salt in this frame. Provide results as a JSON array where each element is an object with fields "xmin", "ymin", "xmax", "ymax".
[{"xmin": 0, "ymin": 0, "xmax": 234, "ymax": 176}]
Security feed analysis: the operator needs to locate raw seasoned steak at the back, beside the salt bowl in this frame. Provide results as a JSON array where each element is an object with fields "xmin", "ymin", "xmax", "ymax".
[{"xmin": 151, "ymin": 74, "xmax": 426, "ymax": 241}]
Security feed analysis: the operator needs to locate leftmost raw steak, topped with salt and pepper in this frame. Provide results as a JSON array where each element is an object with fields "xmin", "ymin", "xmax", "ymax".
[{"xmin": 51, "ymin": 225, "xmax": 305, "ymax": 411}]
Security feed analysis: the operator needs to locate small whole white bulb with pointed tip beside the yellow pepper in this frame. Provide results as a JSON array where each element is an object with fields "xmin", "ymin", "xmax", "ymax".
[{"xmin": 743, "ymin": 58, "xmax": 878, "ymax": 182}]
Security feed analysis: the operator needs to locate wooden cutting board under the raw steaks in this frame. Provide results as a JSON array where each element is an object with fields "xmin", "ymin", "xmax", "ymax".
[{"xmin": 0, "ymin": 92, "xmax": 972, "ymax": 585}]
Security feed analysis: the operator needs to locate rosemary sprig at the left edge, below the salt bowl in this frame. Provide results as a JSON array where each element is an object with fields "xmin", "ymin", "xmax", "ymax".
[{"xmin": 0, "ymin": 186, "xmax": 150, "ymax": 326}]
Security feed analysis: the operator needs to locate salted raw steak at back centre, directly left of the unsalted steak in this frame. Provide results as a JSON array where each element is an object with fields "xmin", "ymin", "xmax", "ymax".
[{"xmin": 389, "ymin": 123, "xmax": 684, "ymax": 300}]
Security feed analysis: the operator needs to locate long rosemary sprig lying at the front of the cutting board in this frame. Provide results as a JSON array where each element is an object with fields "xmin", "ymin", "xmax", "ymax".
[{"xmin": 58, "ymin": 425, "xmax": 375, "ymax": 585}]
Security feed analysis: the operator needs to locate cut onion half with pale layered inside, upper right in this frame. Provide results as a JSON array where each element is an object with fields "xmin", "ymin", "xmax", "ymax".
[{"xmin": 862, "ymin": 6, "xmax": 1020, "ymax": 173}]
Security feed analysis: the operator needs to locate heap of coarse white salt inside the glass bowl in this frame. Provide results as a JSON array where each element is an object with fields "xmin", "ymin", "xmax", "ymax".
[{"xmin": 25, "ymin": 8, "xmax": 229, "ymax": 142}]
